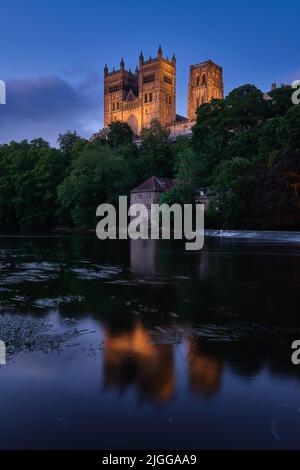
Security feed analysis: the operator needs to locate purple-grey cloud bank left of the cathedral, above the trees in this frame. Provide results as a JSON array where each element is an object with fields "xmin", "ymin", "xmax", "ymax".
[{"xmin": 0, "ymin": 73, "xmax": 103, "ymax": 144}]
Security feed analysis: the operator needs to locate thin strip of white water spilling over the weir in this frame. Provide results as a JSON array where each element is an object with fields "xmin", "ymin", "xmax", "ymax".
[{"xmin": 205, "ymin": 230, "xmax": 300, "ymax": 243}]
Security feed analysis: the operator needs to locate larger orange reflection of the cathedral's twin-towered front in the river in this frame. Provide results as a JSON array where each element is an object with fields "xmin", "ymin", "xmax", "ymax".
[{"xmin": 104, "ymin": 322, "xmax": 174, "ymax": 402}]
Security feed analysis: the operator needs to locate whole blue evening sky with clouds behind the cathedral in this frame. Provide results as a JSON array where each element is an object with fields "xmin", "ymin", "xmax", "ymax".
[{"xmin": 0, "ymin": 0, "xmax": 300, "ymax": 144}]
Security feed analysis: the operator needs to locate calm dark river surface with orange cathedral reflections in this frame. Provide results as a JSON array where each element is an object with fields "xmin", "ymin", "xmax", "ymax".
[{"xmin": 0, "ymin": 237, "xmax": 300, "ymax": 449}]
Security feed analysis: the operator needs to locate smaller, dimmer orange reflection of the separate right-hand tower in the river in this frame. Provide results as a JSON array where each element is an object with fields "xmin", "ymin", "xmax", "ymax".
[{"xmin": 189, "ymin": 344, "xmax": 222, "ymax": 396}]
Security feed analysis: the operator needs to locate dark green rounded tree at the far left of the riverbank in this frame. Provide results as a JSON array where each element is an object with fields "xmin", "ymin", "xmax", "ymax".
[{"xmin": 0, "ymin": 139, "xmax": 68, "ymax": 231}]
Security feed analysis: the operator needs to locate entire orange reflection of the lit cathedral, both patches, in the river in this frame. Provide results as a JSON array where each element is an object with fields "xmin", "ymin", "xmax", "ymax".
[{"xmin": 104, "ymin": 322, "xmax": 222, "ymax": 403}]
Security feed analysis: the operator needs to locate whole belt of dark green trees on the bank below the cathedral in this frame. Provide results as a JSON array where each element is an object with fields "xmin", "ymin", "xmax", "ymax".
[{"xmin": 0, "ymin": 85, "xmax": 300, "ymax": 231}]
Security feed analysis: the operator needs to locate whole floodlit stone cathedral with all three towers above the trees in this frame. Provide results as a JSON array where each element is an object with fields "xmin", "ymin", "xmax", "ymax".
[{"xmin": 104, "ymin": 47, "xmax": 224, "ymax": 136}]
